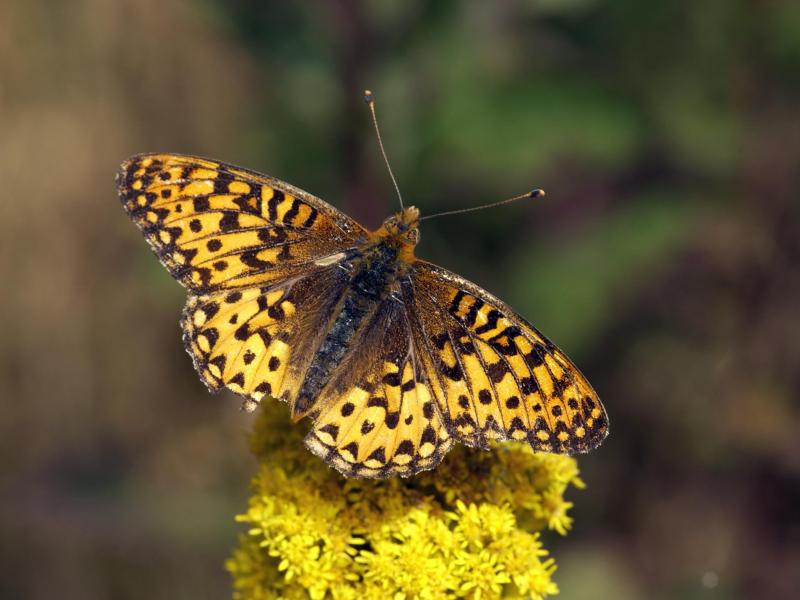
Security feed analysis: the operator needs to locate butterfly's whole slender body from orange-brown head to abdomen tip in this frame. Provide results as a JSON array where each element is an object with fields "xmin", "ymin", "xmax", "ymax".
[{"xmin": 292, "ymin": 207, "xmax": 419, "ymax": 420}]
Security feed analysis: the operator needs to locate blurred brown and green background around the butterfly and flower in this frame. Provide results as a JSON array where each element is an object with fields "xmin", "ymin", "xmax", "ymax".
[{"xmin": 0, "ymin": 0, "xmax": 800, "ymax": 600}]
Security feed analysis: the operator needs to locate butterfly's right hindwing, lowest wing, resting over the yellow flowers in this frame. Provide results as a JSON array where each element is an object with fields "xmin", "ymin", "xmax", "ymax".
[{"xmin": 305, "ymin": 296, "xmax": 452, "ymax": 477}]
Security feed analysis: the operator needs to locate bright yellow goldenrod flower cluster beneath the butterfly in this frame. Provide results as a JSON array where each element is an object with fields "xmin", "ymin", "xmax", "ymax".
[{"xmin": 226, "ymin": 406, "xmax": 583, "ymax": 600}]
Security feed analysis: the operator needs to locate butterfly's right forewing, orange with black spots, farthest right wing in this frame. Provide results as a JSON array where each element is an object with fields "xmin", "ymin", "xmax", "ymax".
[{"xmin": 403, "ymin": 261, "xmax": 608, "ymax": 454}]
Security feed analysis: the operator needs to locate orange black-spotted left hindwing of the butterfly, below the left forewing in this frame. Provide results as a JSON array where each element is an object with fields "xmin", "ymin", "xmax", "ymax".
[{"xmin": 188, "ymin": 265, "xmax": 354, "ymax": 406}]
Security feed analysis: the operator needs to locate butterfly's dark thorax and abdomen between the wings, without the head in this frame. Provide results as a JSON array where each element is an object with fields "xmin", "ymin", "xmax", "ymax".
[{"xmin": 292, "ymin": 243, "xmax": 399, "ymax": 419}]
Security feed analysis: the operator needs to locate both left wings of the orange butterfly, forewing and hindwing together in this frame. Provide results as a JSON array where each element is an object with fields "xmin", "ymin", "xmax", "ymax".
[{"xmin": 117, "ymin": 154, "xmax": 366, "ymax": 402}]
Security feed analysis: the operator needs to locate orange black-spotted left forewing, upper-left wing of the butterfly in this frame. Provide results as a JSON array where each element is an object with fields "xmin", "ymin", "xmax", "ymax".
[{"xmin": 117, "ymin": 154, "xmax": 366, "ymax": 294}]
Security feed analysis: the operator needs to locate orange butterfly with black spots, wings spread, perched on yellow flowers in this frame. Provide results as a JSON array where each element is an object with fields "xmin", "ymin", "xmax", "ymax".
[{"xmin": 117, "ymin": 154, "xmax": 608, "ymax": 478}]
